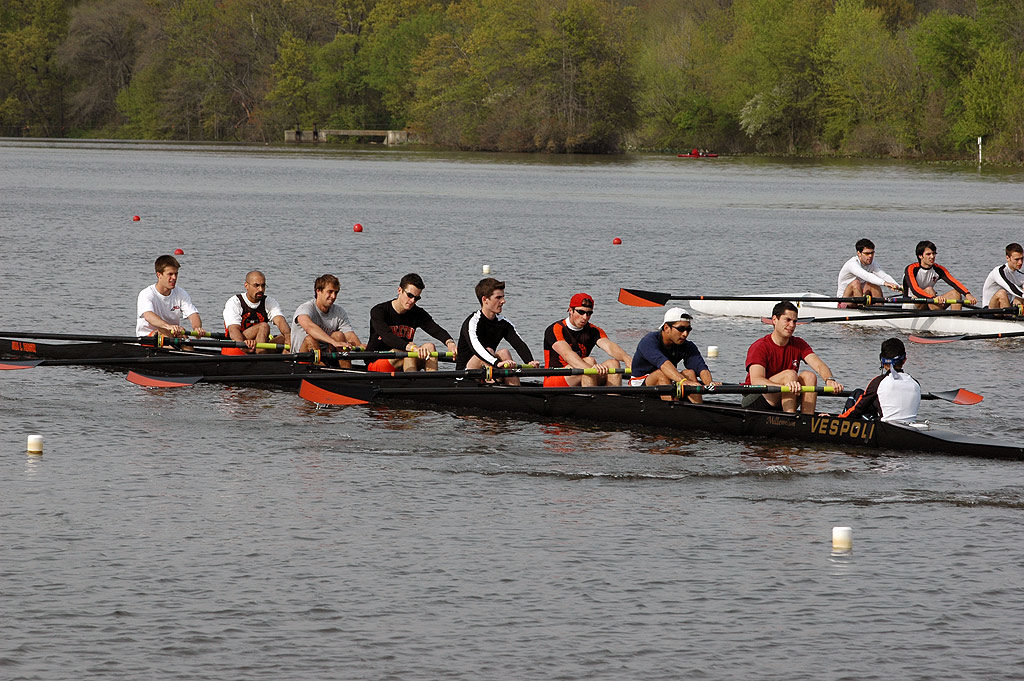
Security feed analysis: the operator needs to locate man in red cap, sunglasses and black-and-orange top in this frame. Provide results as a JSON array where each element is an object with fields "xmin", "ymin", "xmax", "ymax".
[{"xmin": 544, "ymin": 293, "xmax": 633, "ymax": 387}]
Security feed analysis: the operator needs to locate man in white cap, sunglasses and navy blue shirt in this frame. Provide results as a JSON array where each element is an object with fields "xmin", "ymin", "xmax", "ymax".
[{"xmin": 630, "ymin": 307, "xmax": 712, "ymax": 402}]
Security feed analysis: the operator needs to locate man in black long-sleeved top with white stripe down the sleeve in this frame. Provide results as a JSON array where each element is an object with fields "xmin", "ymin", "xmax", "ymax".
[{"xmin": 456, "ymin": 276, "xmax": 540, "ymax": 385}]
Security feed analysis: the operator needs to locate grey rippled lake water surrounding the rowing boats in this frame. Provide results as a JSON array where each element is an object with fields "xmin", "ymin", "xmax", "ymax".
[{"xmin": 0, "ymin": 140, "xmax": 1024, "ymax": 681}]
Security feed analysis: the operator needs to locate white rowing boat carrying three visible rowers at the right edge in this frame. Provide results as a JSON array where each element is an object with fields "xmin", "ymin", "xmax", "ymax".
[{"xmin": 682, "ymin": 291, "xmax": 1024, "ymax": 334}]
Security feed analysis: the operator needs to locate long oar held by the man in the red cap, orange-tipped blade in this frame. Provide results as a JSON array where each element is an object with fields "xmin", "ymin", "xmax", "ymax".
[{"xmin": 126, "ymin": 368, "xmax": 630, "ymax": 388}]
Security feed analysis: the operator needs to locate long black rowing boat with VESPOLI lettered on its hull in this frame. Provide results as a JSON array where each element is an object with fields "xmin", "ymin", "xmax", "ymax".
[{"xmin": 6, "ymin": 339, "xmax": 1024, "ymax": 459}]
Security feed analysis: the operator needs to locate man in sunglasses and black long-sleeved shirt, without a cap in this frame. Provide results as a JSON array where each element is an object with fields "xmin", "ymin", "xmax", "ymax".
[{"xmin": 367, "ymin": 272, "xmax": 458, "ymax": 372}]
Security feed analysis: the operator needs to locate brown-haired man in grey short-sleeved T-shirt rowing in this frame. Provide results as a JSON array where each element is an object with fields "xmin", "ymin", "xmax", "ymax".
[{"xmin": 291, "ymin": 274, "xmax": 361, "ymax": 369}]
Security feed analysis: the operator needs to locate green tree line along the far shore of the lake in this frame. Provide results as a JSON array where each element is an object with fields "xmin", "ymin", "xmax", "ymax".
[{"xmin": 0, "ymin": 0, "xmax": 1024, "ymax": 158}]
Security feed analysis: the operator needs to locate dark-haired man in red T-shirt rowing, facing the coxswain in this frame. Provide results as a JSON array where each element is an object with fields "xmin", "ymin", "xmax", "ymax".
[{"xmin": 742, "ymin": 300, "xmax": 843, "ymax": 414}]
